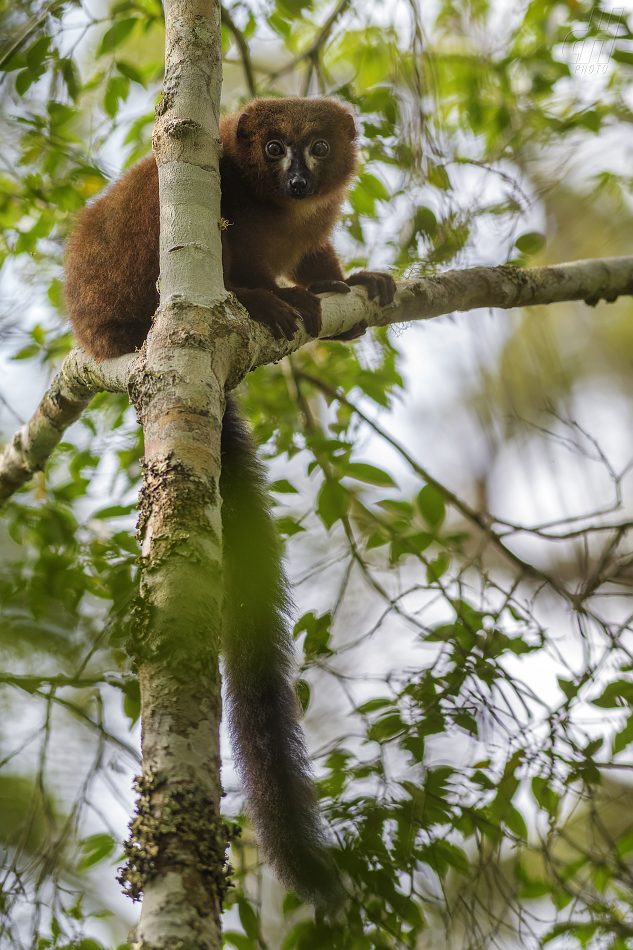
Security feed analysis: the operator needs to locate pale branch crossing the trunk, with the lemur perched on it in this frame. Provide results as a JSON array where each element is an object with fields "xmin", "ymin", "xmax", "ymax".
[{"xmin": 0, "ymin": 257, "xmax": 633, "ymax": 503}]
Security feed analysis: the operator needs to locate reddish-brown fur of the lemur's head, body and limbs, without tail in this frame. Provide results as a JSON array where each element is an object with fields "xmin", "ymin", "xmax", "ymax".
[{"xmin": 66, "ymin": 98, "xmax": 394, "ymax": 359}]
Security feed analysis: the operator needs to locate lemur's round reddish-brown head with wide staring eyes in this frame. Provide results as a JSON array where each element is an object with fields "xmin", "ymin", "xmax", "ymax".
[{"xmin": 230, "ymin": 98, "xmax": 357, "ymax": 204}]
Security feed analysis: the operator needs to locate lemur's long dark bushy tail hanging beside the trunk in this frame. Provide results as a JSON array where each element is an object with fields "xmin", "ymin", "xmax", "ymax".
[{"xmin": 220, "ymin": 400, "xmax": 338, "ymax": 904}]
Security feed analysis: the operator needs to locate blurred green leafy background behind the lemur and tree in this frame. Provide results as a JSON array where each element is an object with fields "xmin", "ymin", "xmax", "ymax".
[{"xmin": 0, "ymin": 0, "xmax": 633, "ymax": 950}]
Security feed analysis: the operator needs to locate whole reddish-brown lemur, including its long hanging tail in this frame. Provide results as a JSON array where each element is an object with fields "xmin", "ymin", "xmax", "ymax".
[{"xmin": 65, "ymin": 98, "xmax": 395, "ymax": 903}]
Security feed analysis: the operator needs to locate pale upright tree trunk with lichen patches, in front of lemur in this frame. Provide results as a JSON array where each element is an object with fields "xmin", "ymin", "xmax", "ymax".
[{"xmin": 115, "ymin": 0, "xmax": 235, "ymax": 950}]
